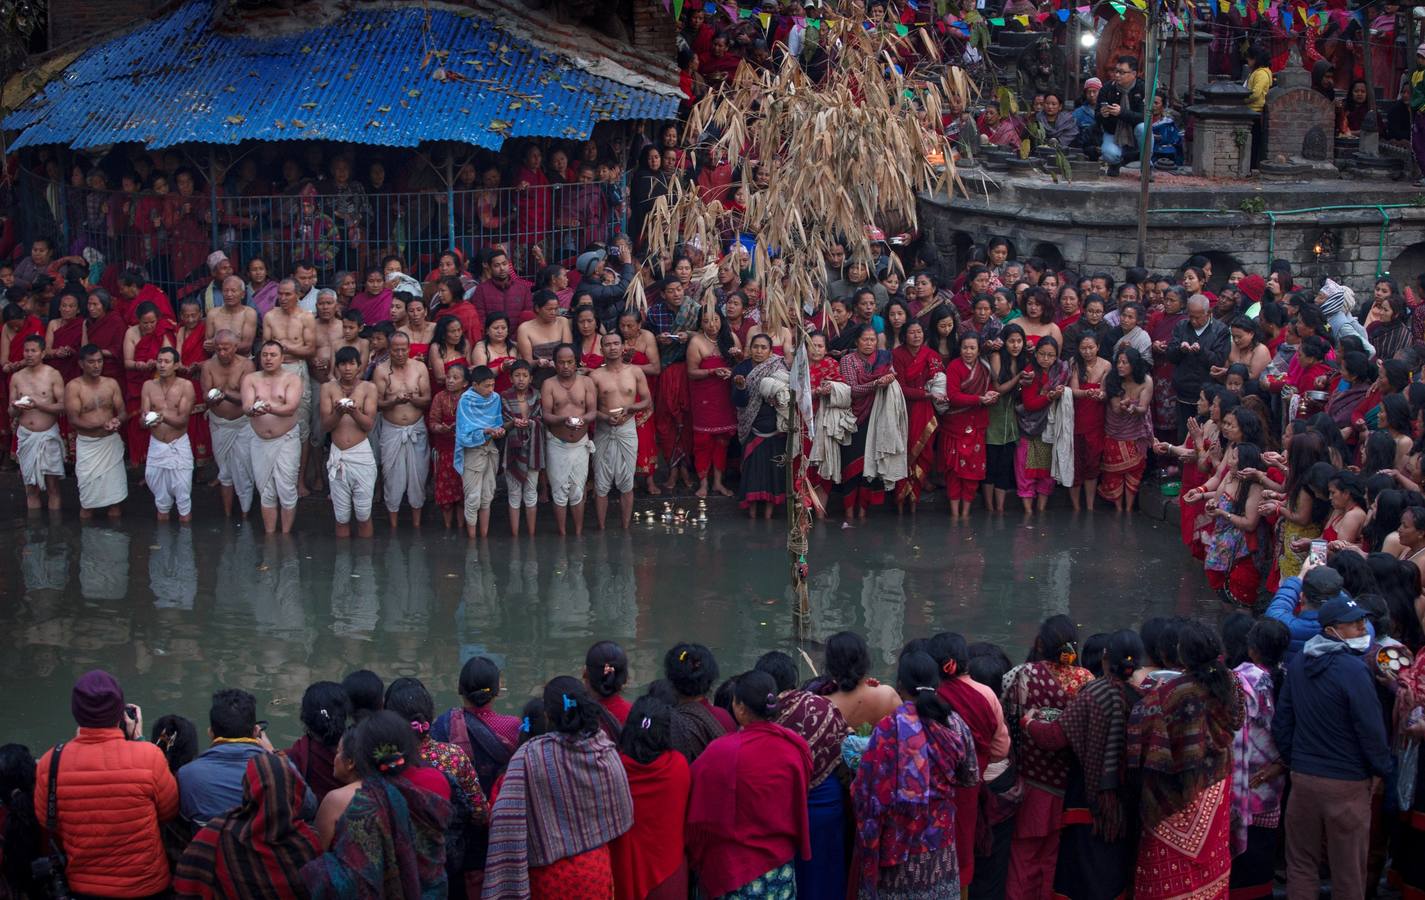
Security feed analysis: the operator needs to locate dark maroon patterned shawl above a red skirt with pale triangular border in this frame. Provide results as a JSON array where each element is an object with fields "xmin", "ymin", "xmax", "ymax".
[{"xmin": 1129, "ymin": 675, "xmax": 1245, "ymax": 829}]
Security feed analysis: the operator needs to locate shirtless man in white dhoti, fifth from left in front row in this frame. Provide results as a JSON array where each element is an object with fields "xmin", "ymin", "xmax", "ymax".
[{"xmin": 242, "ymin": 340, "xmax": 302, "ymax": 534}]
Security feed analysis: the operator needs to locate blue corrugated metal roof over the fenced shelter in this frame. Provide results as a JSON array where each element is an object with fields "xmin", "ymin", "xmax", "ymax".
[{"xmin": 0, "ymin": 0, "xmax": 678, "ymax": 150}]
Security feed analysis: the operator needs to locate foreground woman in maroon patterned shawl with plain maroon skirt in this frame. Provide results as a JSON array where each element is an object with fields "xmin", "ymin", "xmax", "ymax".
[{"xmin": 1000, "ymin": 615, "xmax": 1093, "ymax": 897}]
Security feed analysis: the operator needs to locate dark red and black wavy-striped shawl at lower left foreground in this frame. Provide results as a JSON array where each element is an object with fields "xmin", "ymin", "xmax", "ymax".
[{"xmin": 174, "ymin": 753, "xmax": 319, "ymax": 900}]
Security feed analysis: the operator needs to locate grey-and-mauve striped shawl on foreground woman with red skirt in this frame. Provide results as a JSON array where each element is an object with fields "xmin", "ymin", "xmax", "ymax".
[{"xmin": 482, "ymin": 732, "xmax": 633, "ymax": 897}]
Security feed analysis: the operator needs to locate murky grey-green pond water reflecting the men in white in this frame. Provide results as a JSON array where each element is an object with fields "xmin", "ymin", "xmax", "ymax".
[{"xmin": 0, "ymin": 510, "xmax": 1217, "ymax": 746}]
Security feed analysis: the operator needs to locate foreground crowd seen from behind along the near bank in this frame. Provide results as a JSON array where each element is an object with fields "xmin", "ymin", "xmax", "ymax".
[{"xmin": 0, "ymin": 600, "xmax": 1425, "ymax": 900}]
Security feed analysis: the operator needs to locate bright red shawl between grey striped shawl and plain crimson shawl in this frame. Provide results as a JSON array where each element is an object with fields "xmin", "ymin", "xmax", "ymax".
[{"xmin": 608, "ymin": 746, "xmax": 693, "ymax": 900}]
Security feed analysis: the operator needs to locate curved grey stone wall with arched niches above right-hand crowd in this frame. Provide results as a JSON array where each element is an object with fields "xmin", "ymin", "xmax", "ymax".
[{"xmin": 919, "ymin": 179, "xmax": 1425, "ymax": 284}]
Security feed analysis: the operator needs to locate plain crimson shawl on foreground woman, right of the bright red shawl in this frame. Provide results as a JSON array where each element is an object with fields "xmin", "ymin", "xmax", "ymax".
[{"xmin": 687, "ymin": 722, "xmax": 811, "ymax": 897}]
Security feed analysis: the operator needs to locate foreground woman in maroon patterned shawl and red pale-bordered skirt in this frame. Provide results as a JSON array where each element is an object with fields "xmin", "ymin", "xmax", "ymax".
[{"xmin": 1127, "ymin": 622, "xmax": 1245, "ymax": 900}]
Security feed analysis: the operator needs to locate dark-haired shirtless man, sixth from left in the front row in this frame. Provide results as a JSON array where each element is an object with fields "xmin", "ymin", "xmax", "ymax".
[{"xmin": 318, "ymin": 347, "xmax": 376, "ymax": 537}]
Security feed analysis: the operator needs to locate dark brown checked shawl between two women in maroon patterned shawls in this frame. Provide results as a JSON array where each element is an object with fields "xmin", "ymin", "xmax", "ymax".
[{"xmin": 1059, "ymin": 678, "xmax": 1140, "ymax": 817}]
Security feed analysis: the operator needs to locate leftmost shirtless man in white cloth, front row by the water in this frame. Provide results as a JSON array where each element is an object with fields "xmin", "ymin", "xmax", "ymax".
[{"xmin": 10, "ymin": 335, "xmax": 64, "ymax": 510}]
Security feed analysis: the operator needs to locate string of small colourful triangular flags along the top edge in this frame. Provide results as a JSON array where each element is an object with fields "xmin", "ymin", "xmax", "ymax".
[{"xmin": 663, "ymin": 0, "xmax": 1396, "ymax": 37}]
